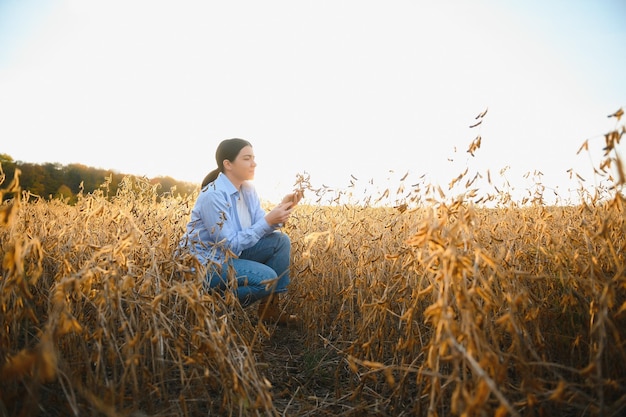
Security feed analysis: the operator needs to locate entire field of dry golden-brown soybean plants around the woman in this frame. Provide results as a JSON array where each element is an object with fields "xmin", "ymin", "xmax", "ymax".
[{"xmin": 0, "ymin": 114, "xmax": 626, "ymax": 417}]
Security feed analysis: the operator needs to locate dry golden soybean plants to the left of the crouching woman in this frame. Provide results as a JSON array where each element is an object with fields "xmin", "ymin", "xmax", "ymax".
[{"xmin": 0, "ymin": 178, "xmax": 271, "ymax": 415}]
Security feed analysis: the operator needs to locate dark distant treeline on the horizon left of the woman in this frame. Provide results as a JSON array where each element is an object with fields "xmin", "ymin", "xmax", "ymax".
[{"xmin": 0, "ymin": 153, "xmax": 198, "ymax": 203}]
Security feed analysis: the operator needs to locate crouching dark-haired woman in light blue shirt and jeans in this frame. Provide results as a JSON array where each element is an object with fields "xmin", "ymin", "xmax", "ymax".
[{"xmin": 181, "ymin": 138, "xmax": 302, "ymax": 323}]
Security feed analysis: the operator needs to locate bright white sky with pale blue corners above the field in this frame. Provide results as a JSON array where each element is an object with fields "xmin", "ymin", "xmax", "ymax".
[{"xmin": 0, "ymin": 0, "xmax": 626, "ymax": 202}]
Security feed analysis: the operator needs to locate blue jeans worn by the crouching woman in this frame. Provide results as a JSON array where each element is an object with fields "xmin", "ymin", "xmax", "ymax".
[{"xmin": 207, "ymin": 232, "xmax": 291, "ymax": 307}]
